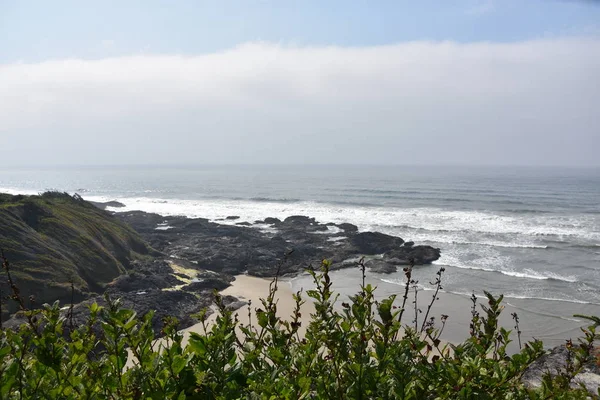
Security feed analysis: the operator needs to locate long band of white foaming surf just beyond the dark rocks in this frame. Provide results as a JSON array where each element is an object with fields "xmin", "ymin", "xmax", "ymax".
[{"xmin": 5, "ymin": 188, "xmax": 600, "ymax": 244}]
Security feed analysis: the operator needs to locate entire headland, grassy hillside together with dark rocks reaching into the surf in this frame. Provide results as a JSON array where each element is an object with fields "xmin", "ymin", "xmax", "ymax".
[{"xmin": 0, "ymin": 193, "xmax": 440, "ymax": 333}]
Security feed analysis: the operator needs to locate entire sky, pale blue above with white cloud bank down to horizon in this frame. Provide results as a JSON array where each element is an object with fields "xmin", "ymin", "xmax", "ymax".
[{"xmin": 0, "ymin": 0, "xmax": 600, "ymax": 167}]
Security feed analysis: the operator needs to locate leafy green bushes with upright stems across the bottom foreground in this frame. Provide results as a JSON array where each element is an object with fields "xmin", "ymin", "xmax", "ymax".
[{"xmin": 0, "ymin": 262, "xmax": 595, "ymax": 399}]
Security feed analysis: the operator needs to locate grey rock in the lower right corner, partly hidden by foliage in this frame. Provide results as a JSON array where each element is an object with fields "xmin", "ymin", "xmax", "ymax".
[{"xmin": 521, "ymin": 345, "xmax": 600, "ymax": 395}]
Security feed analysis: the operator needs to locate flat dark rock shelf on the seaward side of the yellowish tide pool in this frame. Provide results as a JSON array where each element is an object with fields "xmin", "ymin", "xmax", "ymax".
[{"xmin": 116, "ymin": 212, "xmax": 440, "ymax": 276}]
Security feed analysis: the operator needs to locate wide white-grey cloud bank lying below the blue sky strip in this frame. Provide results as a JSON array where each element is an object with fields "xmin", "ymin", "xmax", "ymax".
[{"xmin": 0, "ymin": 38, "xmax": 600, "ymax": 165}]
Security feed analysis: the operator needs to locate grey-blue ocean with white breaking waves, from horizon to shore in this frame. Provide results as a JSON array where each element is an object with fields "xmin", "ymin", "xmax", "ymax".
[{"xmin": 0, "ymin": 164, "xmax": 600, "ymax": 342}]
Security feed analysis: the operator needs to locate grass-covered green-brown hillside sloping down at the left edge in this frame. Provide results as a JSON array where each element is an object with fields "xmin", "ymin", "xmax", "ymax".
[{"xmin": 0, "ymin": 192, "xmax": 150, "ymax": 312}]
